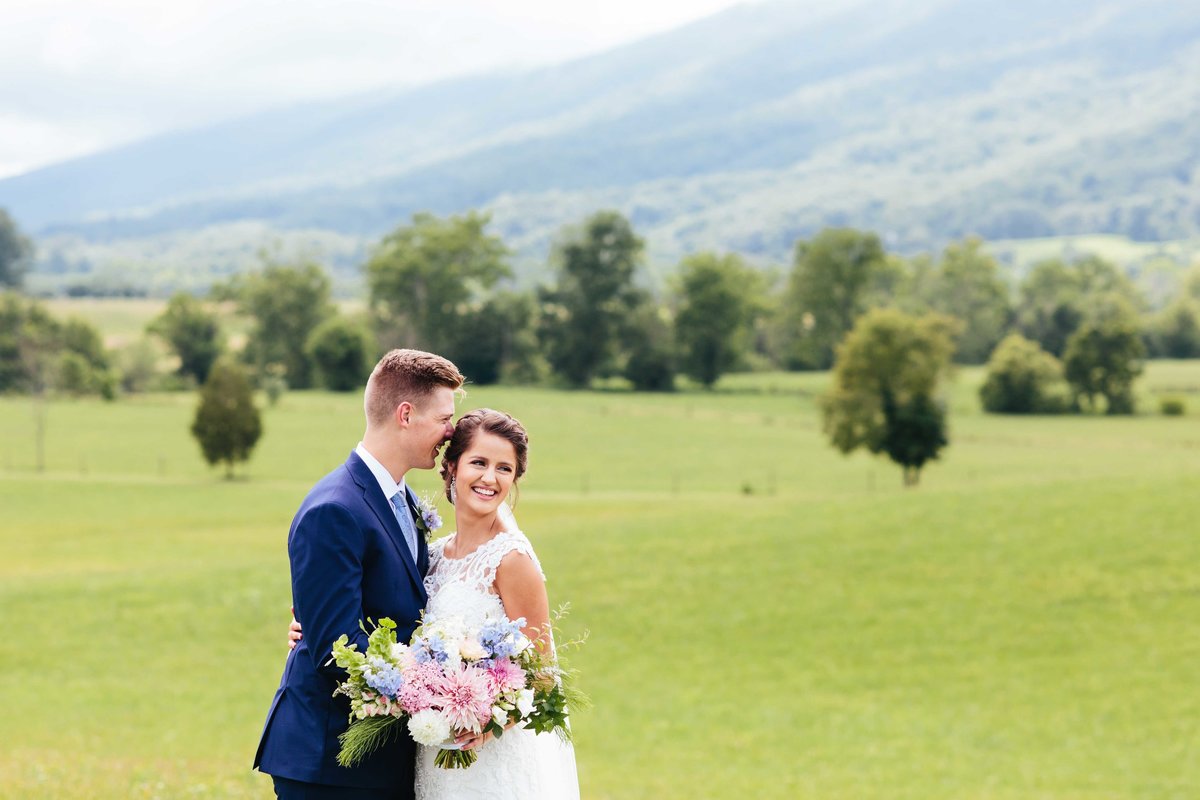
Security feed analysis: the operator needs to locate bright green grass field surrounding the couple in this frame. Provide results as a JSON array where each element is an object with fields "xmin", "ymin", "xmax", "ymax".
[{"xmin": 0, "ymin": 363, "xmax": 1200, "ymax": 800}]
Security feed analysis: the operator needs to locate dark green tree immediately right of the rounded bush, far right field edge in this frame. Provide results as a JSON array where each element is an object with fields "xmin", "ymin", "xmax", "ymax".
[{"xmin": 1062, "ymin": 294, "xmax": 1146, "ymax": 414}]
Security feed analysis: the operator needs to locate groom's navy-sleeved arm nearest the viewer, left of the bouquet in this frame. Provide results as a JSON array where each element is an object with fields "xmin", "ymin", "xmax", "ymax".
[{"xmin": 288, "ymin": 504, "xmax": 367, "ymax": 680}]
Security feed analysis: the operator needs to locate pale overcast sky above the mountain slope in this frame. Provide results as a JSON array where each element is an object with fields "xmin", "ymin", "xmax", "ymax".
[{"xmin": 0, "ymin": 0, "xmax": 738, "ymax": 178}]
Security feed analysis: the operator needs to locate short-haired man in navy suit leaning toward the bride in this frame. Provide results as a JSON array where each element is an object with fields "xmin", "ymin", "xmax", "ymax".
[{"xmin": 254, "ymin": 350, "xmax": 463, "ymax": 800}]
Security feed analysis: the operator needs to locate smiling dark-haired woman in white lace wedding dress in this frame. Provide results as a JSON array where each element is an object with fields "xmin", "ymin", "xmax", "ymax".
[{"xmin": 285, "ymin": 409, "xmax": 580, "ymax": 800}]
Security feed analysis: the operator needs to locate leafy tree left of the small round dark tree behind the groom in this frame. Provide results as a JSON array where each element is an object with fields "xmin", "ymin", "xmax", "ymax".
[{"xmin": 233, "ymin": 263, "xmax": 336, "ymax": 389}]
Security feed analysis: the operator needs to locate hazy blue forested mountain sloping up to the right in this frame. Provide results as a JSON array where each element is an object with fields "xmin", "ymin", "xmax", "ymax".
[{"xmin": 0, "ymin": 0, "xmax": 1200, "ymax": 291}]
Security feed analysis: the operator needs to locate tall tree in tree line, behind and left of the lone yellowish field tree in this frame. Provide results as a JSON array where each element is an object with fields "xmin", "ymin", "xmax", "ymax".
[{"xmin": 785, "ymin": 228, "xmax": 893, "ymax": 368}]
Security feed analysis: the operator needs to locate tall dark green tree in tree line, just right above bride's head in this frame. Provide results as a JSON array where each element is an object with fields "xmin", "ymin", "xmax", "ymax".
[{"xmin": 539, "ymin": 211, "xmax": 642, "ymax": 386}]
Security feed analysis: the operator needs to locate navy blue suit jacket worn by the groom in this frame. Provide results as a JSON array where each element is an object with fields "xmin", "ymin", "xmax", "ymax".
[{"xmin": 254, "ymin": 452, "xmax": 428, "ymax": 792}]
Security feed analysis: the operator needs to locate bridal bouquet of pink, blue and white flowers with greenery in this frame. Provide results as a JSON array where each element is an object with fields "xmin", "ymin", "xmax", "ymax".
[{"xmin": 332, "ymin": 615, "xmax": 582, "ymax": 769}]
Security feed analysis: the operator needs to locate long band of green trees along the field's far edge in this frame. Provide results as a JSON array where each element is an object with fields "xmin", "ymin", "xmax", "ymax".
[{"xmin": 0, "ymin": 203, "xmax": 1200, "ymax": 402}]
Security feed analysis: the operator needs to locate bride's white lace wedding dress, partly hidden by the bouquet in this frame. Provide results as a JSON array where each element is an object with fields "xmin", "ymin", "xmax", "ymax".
[{"xmin": 416, "ymin": 515, "xmax": 580, "ymax": 800}]
